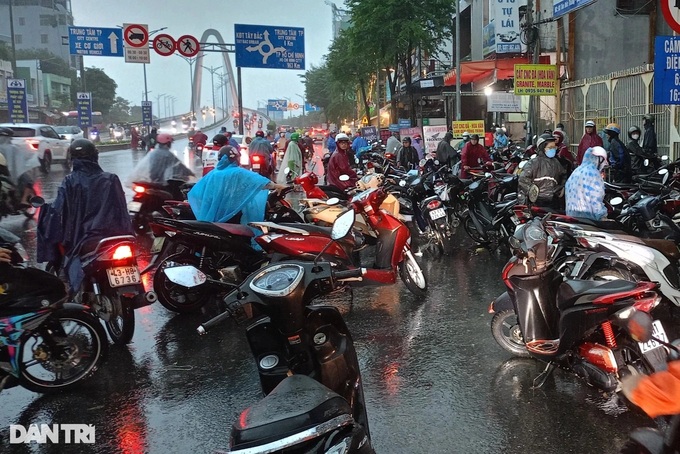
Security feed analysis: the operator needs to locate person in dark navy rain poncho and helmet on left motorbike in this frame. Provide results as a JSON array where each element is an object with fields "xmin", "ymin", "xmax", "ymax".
[{"xmin": 37, "ymin": 139, "xmax": 135, "ymax": 294}]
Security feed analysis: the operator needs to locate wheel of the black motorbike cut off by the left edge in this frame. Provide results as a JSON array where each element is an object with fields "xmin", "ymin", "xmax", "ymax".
[{"xmin": 17, "ymin": 309, "xmax": 109, "ymax": 393}]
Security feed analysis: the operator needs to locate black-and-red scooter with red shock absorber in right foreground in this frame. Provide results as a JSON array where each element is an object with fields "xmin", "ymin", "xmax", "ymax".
[{"xmin": 489, "ymin": 218, "xmax": 667, "ymax": 391}]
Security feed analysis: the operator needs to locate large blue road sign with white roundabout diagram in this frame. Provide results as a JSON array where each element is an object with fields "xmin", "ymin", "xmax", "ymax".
[{"xmin": 234, "ymin": 24, "xmax": 305, "ymax": 69}]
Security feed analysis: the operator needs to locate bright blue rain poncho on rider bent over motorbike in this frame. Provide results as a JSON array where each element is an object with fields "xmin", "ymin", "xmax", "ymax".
[{"xmin": 187, "ymin": 156, "xmax": 270, "ymax": 229}]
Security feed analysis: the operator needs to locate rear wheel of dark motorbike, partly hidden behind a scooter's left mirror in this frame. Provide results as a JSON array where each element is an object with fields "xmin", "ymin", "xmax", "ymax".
[{"xmin": 153, "ymin": 253, "xmax": 214, "ymax": 314}]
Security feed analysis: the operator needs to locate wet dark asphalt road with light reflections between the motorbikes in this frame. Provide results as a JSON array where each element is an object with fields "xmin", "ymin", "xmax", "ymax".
[{"xmin": 0, "ymin": 141, "xmax": 668, "ymax": 454}]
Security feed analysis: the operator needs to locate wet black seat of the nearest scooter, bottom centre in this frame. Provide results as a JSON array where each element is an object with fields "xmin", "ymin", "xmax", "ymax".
[{"xmin": 231, "ymin": 375, "xmax": 352, "ymax": 452}]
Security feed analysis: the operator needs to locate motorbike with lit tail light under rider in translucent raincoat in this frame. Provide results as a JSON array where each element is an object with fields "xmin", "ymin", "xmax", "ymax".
[{"xmin": 128, "ymin": 179, "xmax": 193, "ymax": 232}]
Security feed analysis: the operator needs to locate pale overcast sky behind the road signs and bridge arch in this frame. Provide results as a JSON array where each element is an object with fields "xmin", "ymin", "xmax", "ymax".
[{"xmin": 72, "ymin": 0, "xmax": 334, "ymax": 117}]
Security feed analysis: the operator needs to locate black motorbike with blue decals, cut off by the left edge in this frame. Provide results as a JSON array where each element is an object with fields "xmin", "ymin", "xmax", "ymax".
[{"xmin": 0, "ymin": 229, "xmax": 108, "ymax": 393}]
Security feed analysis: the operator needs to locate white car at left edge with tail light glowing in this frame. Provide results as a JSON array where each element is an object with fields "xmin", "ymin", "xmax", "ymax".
[{"xmin": 0, "ymin": 123, "xmax": 71, "ymax": 174}]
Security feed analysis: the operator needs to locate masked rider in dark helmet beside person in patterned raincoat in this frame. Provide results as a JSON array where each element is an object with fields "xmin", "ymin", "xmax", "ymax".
[{"xmin": 517, "ymin": 134, "xmax": 566, "ymax": 209}]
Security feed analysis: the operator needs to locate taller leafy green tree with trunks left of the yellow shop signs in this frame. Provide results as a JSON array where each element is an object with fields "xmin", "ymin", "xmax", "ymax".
[{"xmin": 347, "ymin": 0, "xmax": 456, "ymax": 123}]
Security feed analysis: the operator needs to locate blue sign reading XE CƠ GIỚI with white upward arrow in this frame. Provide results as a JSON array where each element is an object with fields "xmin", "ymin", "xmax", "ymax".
[{"xmin": 68, "ymin": 27, "xmax": 123, "ymax": 57}]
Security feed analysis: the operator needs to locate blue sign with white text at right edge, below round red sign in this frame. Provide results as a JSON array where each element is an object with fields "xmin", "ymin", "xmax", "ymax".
[{"xmin": 654, "ymin": 36, "xmax": 680, "ymax": 104}]
